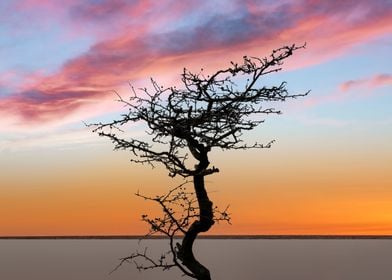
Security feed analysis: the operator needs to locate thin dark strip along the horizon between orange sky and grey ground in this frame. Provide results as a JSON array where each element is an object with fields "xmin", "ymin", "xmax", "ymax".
[{"xmin": 0, "ymin": 234, "xmax": 392, "ymax": 239}]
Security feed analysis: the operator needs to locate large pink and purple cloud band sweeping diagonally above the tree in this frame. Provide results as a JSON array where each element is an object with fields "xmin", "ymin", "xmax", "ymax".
[{"xmin": 0, "ymin": 0, "xmax": 392, "ymax": 129}]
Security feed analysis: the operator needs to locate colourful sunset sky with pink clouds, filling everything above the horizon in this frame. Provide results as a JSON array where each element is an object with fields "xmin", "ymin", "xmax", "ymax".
[{"xmin": 0, "ymin": 0, "xmax": 392, "ymax": 236}]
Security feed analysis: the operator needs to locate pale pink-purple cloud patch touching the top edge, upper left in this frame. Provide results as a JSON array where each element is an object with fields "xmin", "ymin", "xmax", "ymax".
[{"xmin": 11, "ymin": 0, "xmax": 200, "ymax": 41}]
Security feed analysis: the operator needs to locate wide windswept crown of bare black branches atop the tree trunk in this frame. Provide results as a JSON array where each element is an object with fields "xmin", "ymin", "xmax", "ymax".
[{"xmin": 95, "ymin": 45, "xmax": 308, "ymax": 177}]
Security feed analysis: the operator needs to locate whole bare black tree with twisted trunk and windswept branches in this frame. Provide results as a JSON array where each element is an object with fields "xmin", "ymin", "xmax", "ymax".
[{"xmin": 94, "ymin": 45, "xmax": 308, "ymax": 280}]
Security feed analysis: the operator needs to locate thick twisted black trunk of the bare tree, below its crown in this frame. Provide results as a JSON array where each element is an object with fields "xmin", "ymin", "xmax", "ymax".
[{"xmin": 181, "ymin": 174, "xmax": 214, "ymax": 280}]
